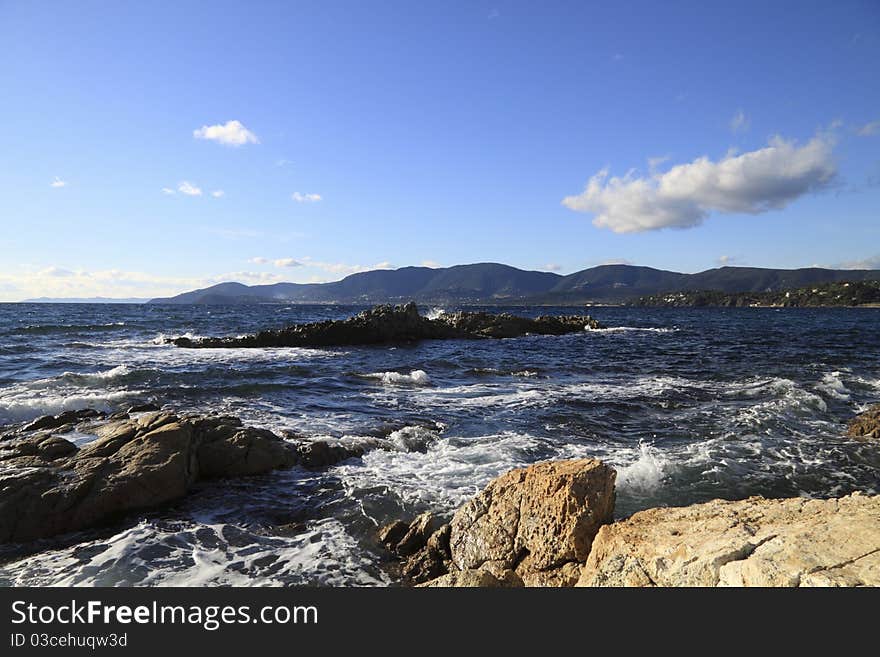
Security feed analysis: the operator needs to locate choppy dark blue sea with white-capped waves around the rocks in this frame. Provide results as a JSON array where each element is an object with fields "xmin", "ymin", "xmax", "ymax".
[{"xmin": 0, "ymin": 304, "xmax": 880, "ymax": 585}]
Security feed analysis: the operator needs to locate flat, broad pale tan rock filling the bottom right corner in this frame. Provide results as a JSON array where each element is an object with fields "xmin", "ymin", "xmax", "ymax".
[{"xmin": 577, "ymin": 493, "xmax": 880, "ymax": 586}]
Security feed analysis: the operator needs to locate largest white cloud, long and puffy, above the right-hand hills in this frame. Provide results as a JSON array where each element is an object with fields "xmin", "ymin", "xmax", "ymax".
[{"xmin": 562, "ymin": 135, "xmax": 837, "ymax": 233}]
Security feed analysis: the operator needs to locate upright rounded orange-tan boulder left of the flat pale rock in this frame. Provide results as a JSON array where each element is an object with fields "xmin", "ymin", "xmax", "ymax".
[{"xmin": 449, "ymin": 459, "xmax": 615, "ymax": 586}]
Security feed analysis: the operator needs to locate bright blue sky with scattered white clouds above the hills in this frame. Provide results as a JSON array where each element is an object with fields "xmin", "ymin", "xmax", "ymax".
[{"xmin": 0, "ymin": 0, "xmax": 880, "ymax": 300}]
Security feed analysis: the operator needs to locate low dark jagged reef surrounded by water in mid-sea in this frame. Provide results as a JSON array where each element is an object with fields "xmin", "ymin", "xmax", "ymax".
[{"xmin": 171, "ymin": 302, "xmax": 600, "ymax": 348}]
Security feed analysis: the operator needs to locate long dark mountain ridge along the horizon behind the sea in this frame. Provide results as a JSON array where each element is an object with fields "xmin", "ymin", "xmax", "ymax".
[{"xmin": 150, "ymin": 263, "xmax": 880, "ymax": 305}]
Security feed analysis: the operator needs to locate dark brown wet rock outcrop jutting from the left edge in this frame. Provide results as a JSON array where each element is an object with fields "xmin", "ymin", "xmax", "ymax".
[{"xmin": 0, "ymin": 412, "xmax": 369, "ymax": 543}]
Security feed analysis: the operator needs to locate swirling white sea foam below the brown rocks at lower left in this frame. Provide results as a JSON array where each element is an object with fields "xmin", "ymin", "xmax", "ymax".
[{"xmin": 0, "ymin": 519, "xmax": 388, "ymax": 586}]
